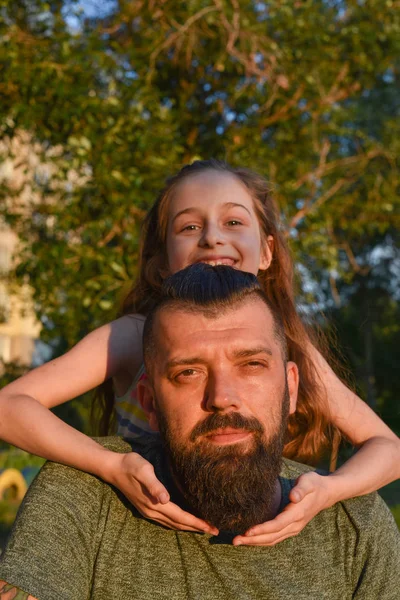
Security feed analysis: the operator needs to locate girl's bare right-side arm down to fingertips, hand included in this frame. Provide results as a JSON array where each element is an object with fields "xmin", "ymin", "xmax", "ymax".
[{"xmin": 234, "ymin": 348, "xmax": 400, "ymax": 546}]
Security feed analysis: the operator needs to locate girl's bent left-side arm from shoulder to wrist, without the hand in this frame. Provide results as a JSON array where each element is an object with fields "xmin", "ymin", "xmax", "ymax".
[{"xmin": 0, "ymin": 317, "xmax": 141, "ymax": 468}]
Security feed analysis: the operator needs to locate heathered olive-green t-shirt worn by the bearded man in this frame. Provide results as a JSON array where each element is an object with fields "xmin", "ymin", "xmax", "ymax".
[{"xmin": 0, "ymin": 438, "xmax": 400, "ymax": 600}]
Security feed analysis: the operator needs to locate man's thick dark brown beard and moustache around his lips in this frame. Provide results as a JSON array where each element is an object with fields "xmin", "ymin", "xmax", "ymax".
[{"xmin": 158, "ymin": 386, "xmax": 289, "ymax": 533}]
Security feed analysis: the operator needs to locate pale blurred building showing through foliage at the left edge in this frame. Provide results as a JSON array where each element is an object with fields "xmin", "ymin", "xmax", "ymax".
[{"xmin": 0, "ymin": 128, "xmax": 91, "ymax": 366}]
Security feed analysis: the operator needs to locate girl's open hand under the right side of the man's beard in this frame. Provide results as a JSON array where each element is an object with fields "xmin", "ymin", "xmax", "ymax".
[{"xmin": 233, "ymin": 472, "xmax": 335, "ymax": 546}]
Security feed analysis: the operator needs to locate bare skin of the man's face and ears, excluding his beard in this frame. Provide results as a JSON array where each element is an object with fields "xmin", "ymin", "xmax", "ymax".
[{"xmin": 144, "ymin": 298, "xmax": 297, "ymax": 452}]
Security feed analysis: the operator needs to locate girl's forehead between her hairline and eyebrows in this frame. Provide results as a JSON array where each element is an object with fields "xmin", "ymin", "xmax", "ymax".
[{"xmin": 170, "ymin": 170, "xmax": 254, "ymax": 214}]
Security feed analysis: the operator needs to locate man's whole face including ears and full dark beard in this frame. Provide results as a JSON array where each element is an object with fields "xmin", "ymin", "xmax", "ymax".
[{"xmin": 139, "ymin": 298, "xmax": 297, "ymax": 531}]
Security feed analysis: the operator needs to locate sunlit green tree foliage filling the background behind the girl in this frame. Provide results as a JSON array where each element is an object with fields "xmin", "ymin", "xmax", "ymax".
[{"xmin": 0, "ymin": 0, "xmax": 400, "ymax": 429}]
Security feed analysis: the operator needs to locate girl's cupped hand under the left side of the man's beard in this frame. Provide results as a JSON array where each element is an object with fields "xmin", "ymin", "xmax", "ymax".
[{"xmin": 107, "ymin": 452, "xmax": 218, "ymax": 535}]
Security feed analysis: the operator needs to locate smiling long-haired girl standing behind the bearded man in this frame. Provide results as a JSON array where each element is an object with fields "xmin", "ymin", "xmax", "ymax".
[{"xmin": 0, "ymin": 160, "xmax": 400, "ymax": 545}]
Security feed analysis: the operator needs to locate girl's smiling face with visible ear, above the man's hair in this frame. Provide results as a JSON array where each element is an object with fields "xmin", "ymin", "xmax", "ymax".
[{"xmin": 167, "ymin": 170, "xmax": 272, "ymax": 275}]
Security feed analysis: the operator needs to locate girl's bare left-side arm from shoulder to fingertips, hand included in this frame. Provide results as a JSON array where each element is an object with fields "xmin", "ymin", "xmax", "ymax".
[{"xmin": 0, "ymin": 316, "xmax": 214, "ymax": 531}]
